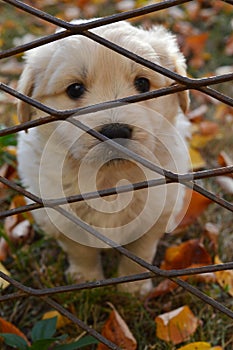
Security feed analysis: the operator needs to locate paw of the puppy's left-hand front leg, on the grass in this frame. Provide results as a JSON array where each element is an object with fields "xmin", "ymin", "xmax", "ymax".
[{"xmin": 66, "ymin": 265, "xmax": 104, "ymax": 283}]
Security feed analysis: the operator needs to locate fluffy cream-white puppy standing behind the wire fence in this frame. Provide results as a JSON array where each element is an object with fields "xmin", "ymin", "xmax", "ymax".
[{"xmin": 18, "ymin": 22, "xmax": 189, "ymax": 293}]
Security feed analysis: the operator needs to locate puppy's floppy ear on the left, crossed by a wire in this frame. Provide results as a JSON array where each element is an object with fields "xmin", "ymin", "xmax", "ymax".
[{"xmin": 17, "ymin": 65, "xmax": 34, "ymax": 123}]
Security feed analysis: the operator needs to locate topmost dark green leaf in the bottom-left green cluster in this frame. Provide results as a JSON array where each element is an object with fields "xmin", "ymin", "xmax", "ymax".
[{"xmin": 31, "ymin": 317, "xmax": 57, "ymax": 342}]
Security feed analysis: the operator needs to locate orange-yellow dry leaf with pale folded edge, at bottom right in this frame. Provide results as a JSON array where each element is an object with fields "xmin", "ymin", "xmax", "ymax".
[{"xmin": 155, "ymin": 305, "xmax": 200, "ymax": 344}]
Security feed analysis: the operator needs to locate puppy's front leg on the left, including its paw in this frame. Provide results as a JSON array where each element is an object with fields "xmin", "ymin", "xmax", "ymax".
[{"xmin": 58, "ymin": 235, "xmax": 104, "ymax": 283}]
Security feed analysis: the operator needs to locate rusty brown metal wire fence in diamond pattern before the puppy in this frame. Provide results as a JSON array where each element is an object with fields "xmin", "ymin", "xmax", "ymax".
[{"xmin": 0, "ymin": 0, "xmax": 233, "ymax": 349}]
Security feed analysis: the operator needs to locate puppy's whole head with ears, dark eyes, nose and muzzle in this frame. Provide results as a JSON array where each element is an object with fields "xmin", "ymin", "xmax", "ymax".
[{"xmin": 19, "ymin": 22, "xmax": 188, "ymax": 170}]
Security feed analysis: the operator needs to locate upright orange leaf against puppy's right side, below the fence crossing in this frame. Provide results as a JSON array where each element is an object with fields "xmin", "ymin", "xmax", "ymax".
[{"xmin": 178, "ymin": 189, "xmax": 213, "ymax": 229}]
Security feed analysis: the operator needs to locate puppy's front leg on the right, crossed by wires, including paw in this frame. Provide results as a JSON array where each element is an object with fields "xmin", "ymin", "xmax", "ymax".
[{"xmin": 118, "ymin": 230, "xmax": 161, "ymax": 295}]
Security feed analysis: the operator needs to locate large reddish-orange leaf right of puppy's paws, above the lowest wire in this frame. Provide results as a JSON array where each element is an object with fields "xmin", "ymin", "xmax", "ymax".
[{"xmin": 161, "ymin": 239, "xmax": 211, "ymax": 270}]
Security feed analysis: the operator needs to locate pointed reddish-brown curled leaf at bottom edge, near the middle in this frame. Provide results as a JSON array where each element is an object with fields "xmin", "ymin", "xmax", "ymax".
[{"xmin": 97, "ymin": 306, "xmax": 137, "ymax": 350}]
